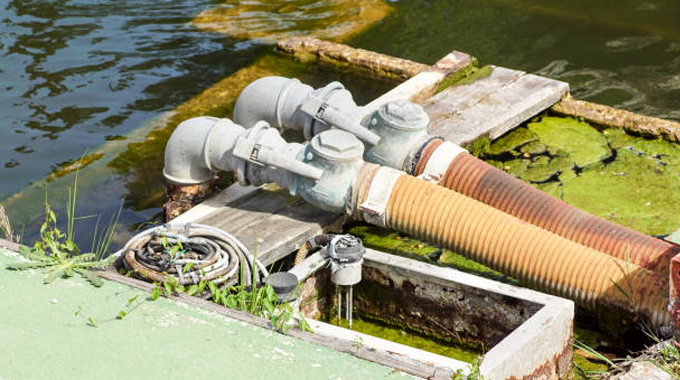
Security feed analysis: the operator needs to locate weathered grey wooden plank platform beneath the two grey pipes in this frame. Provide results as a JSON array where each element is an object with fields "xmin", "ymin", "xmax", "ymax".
[{"xmin": 173, "ymin": 47, "xmax": 569, "ymax": 265}]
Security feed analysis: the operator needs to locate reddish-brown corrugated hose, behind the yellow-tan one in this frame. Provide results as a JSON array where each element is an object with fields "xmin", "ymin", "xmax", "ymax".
[{"xmin": 412, "ymin": 140, "xmax": 680, "ymax": 276}]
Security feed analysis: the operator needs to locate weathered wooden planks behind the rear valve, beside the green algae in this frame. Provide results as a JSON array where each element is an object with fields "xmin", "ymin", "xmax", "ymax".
[{"xmin": 424, "ymin": 67, "xmax": 569, "ymax": 144}]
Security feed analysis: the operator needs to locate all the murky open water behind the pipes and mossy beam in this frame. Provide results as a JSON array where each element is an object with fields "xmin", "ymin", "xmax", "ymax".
[{"xmin": 0, "ymin": 0, "xmax": 680, "ymax": 249}]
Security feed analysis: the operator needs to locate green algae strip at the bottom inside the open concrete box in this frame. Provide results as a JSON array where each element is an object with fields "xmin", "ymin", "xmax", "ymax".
[{"xmin": 325, "ymin": 313, "xmax": 483, "ymax": 363}]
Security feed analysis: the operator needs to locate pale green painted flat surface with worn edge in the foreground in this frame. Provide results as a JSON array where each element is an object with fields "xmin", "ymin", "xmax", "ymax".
[{"xmin": 0, "ymin": 251, "xmax": 414, "ymax": 380}]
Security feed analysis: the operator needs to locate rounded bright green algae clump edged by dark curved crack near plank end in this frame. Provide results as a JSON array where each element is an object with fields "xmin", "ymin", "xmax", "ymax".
[{"xmin": 527, "ymin": 116, "xmax": 612, "ymax": 167}]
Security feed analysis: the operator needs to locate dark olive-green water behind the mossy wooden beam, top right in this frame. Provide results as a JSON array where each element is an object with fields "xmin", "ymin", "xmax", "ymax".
[{"xmin": 350, "ymin": 0, "xmax": 680, "ymax": 120}]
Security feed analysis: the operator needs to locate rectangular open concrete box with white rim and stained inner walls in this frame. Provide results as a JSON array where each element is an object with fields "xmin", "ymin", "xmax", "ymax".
[{"xmin": 291, "ymin": 249, "xmax": 574, "ymax": 380}]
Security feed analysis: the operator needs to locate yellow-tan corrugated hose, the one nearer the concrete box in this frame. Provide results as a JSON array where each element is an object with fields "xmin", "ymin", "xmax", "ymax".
[{"xmin": 355, "ymin": 165, "xmax": 670, "ymax": 328}]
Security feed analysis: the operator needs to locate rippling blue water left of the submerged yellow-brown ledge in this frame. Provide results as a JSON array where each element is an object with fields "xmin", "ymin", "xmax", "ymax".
[{"xmin": 0, "ymin": 0, "xmax": 262, "ymax": 199}]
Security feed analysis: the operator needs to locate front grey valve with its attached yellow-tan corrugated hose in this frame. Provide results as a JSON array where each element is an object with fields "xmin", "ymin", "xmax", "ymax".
[{"xmin": 163, "ymin": 121, "xmax": 670, "ymax": 329}]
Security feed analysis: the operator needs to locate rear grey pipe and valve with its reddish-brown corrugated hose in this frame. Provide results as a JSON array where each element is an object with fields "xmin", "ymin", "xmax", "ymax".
[{"xmin": 234, "ymin": 77, "xmax": 680, "ymax": 275}]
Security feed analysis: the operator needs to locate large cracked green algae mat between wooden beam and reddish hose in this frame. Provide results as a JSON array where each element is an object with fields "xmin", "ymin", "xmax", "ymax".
[{"xmin": 480, "ymin": 116, "xmax": 680, "ymax": 235}]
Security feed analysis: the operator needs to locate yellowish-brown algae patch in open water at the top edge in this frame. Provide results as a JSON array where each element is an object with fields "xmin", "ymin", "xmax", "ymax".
[{"xmin": 192, "ymin": 0, "xmax": 392, "ymax": 42}]
